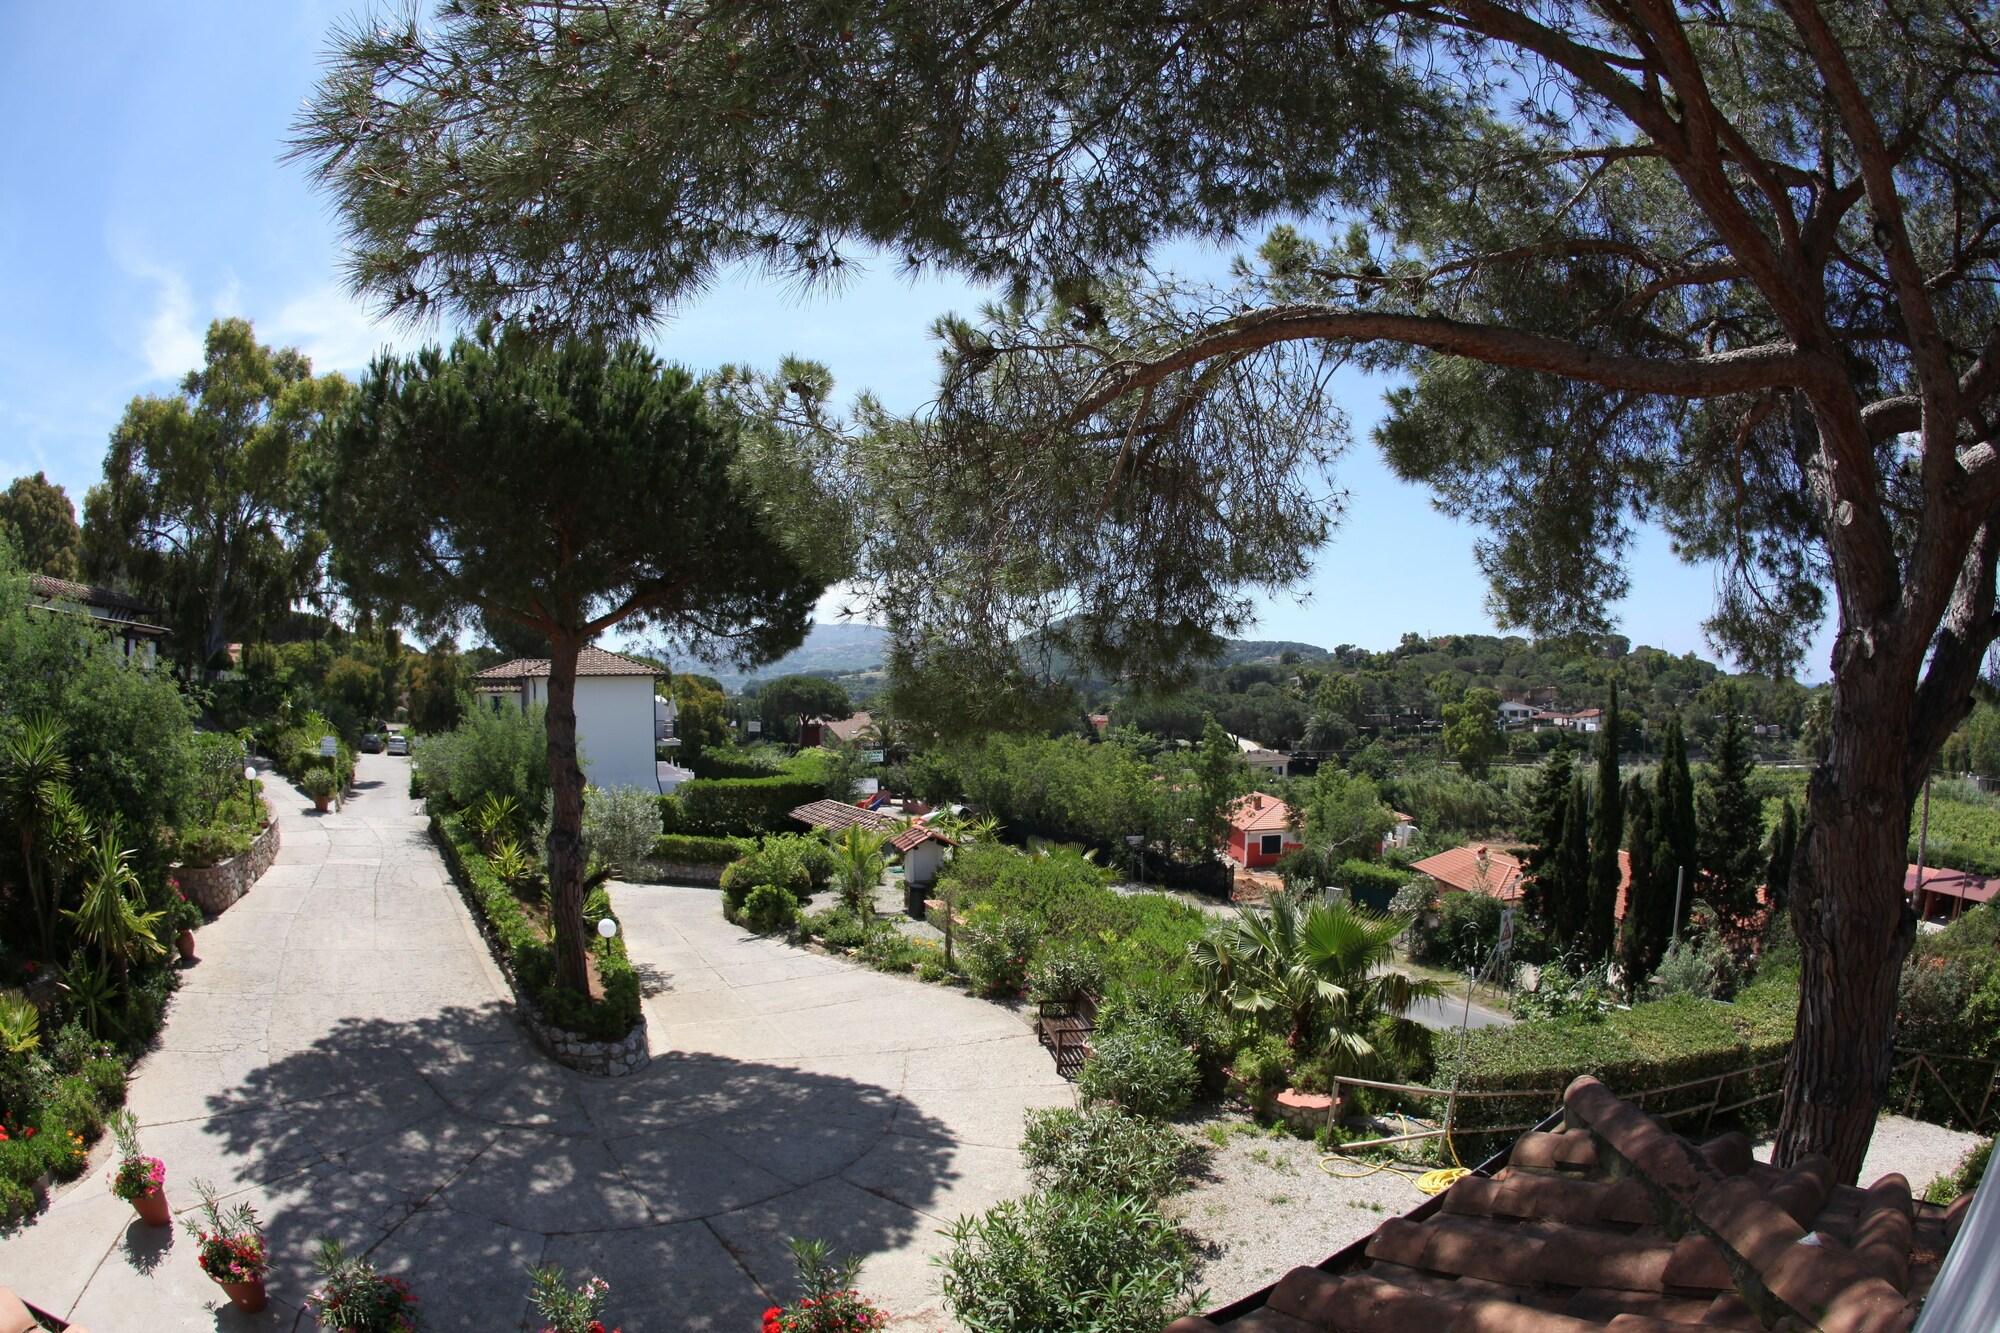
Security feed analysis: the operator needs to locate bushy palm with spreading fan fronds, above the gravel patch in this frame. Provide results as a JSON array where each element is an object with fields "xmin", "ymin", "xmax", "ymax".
[{"xmin": 1188, "ymin": 893, "xmax": 1444, "ymax": 1075}]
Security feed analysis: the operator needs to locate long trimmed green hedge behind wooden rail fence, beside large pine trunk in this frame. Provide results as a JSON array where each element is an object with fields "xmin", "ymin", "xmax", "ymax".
[{"xmin": 1436, "ymin": 975, "xmax": 1798, "ymax": 1163}]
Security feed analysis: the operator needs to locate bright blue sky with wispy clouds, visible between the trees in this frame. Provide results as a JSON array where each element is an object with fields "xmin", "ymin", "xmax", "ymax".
[{"xmin": 0, "ymin": 0, "xmax": 1826, "ymax": 679}]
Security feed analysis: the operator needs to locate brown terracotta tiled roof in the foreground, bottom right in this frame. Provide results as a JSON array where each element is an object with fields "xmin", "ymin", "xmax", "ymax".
[{"xmin": 1168, "ymin": 1075, "xmax": 1970, "ymax": 1333}]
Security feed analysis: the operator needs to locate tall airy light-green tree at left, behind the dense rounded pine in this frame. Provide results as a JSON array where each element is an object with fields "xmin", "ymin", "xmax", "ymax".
[{"xmin": 84, "ymin": 320, "xmax": 350, "ymax": 667}]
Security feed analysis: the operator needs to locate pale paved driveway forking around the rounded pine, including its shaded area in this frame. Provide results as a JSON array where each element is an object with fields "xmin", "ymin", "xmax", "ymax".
[{"xmin": 0, "ymin": 755, "xmax": 1070, "ymax": 1333}]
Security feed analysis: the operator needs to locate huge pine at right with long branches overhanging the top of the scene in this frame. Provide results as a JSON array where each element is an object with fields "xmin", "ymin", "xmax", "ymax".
[{"xmin": 296, "ymin": 0, "xmax": 2000, "ymax": 1179}]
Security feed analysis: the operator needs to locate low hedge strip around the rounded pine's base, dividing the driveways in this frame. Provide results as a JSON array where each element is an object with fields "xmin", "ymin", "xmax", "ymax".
[{"xmin": 430, "ymin": 815, "xmax": 640, "ymax": 1041}]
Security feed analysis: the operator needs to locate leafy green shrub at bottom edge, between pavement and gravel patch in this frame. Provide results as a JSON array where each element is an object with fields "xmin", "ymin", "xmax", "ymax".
[{"xmin": 936, "ymin": 1191, "xmax": 1198, "ymax": 1333}]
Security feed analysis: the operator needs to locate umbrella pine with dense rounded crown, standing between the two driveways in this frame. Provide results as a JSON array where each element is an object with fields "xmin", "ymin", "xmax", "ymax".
[{"xmin": 324, "ymin": 330, "xmax": 826, "ymax": 993}]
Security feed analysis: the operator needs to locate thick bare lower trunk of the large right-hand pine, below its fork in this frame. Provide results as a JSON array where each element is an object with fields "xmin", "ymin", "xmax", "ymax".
[{"xmin": 1776, "ymin": 662, "xmax": 1916, "ymax": 1183}]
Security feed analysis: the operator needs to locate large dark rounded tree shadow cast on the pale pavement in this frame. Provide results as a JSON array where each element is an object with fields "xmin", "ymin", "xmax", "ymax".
[{"xmin": 201, "ymin": 1003, "xmax": 958, "ymax": 1333}]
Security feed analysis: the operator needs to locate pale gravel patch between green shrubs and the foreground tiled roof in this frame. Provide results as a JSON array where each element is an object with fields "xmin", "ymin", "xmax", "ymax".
[{"xmin": 1168, "ymin": 1115, "xmax": 1448, "ymax": 1309}]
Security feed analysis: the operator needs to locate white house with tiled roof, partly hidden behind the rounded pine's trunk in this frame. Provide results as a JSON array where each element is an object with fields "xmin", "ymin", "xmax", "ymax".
[{"xmin": 472, "ymin": 648, "xmax": 662, "ymax": 791}]
